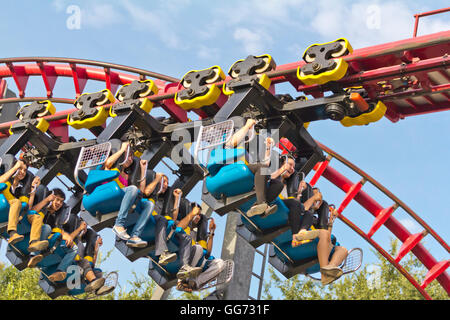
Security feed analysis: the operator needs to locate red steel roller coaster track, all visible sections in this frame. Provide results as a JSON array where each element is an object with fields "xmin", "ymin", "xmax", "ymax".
[{"xmin": 0, "ymin": 31, "xmax": 450, "ymax": 299}]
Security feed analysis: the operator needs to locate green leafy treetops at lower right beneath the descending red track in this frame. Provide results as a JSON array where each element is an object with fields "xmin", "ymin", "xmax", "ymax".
[{"xmin": 264, "ymin": 240, "xmax": 449, "ymax": 300}]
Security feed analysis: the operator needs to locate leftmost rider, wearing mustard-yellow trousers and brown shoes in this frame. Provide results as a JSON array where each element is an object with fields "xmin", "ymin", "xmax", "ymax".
[{"xmin": 0, "ymin": 160, "xmax": 48, "ymax": 252}]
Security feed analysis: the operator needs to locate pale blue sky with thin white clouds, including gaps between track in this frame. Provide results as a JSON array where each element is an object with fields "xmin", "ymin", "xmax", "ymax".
[{"xmin": 0, "ymin": 0, "xmax": 450, "ymax": 298}]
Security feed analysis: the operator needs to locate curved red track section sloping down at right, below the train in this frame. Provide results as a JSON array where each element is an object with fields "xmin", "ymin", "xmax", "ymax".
[{"xmin": 311, "ymin": 142, "xmax": 450, "ymax": 299}]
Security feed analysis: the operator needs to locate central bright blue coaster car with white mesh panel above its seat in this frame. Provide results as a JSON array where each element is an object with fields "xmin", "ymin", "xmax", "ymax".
[{"xmin": 195, "ymin": 120, "xmax": 289, "ymax": 247}]
